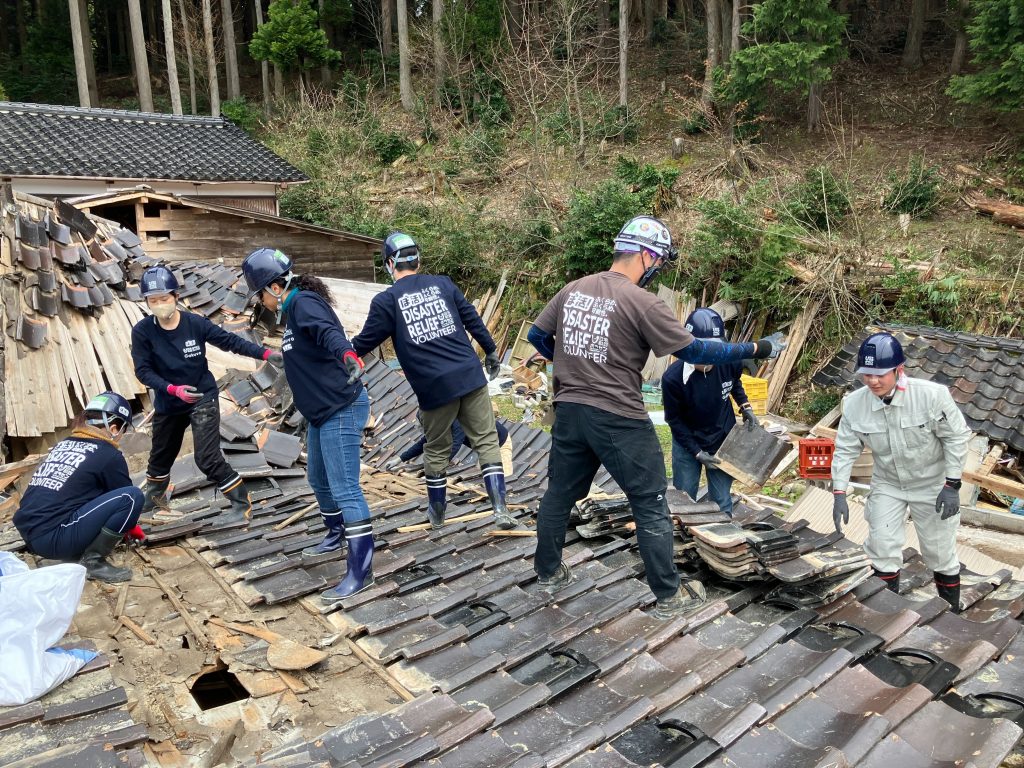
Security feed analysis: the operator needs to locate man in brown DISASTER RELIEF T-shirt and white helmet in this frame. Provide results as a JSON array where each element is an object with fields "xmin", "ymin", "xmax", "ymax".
[{"xmin": 529, "ymin": 216, "xmax": 784, "ymax": 618}]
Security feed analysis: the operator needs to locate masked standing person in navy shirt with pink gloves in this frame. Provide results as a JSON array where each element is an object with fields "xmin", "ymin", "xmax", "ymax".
[{"xmin": 131, "ymin": 266, "xmax": 282, "ymax": 522}]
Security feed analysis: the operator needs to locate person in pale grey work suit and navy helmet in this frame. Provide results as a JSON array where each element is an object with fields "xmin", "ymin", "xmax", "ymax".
[{"xmin": 831, "ymin": 333, "xmax": 971, "ymax": 612}]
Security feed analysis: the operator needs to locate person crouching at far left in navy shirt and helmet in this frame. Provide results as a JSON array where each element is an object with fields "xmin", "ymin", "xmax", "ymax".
[{"xmin": 14, "ymin": 392, "xmax": 142, "ymax": 582}]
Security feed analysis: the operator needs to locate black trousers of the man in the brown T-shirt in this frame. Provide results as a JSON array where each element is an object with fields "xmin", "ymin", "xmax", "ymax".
[{"xmin": 534, "ymin": 402, "xmax": 679, "ymax": 599}]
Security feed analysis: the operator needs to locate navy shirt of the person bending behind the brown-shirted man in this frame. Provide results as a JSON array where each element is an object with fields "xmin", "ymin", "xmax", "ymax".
[{"xmin": 662, "ymin": 360, "xmax": 746, "ymax": 456}]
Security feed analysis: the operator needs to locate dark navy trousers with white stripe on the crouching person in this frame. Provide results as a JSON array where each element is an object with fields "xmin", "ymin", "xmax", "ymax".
[{"xmin": 28, "ymin": 485, "xmax": 143, "ymax": 560}]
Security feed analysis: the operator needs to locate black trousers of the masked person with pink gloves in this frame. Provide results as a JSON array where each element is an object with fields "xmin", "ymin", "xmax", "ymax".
[{"xmin": 146, "ymin": 397, "xmax": 239, "ymax": 490}]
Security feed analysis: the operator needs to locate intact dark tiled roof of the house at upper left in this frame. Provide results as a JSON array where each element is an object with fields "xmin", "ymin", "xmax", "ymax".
[{"xmin": 0, "ymin": 101, "xmax": 308, "ymax": 183}]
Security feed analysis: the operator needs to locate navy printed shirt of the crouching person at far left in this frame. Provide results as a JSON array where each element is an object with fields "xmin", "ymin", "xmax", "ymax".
[{"xmin": 14, "ymin": 432, "xmax": 132, "ymax": 543}]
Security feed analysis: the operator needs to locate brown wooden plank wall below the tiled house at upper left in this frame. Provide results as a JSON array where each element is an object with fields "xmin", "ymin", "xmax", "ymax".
[{"xmin": 132, "ymin": 204, "xmax": 379, "ymax": 281}]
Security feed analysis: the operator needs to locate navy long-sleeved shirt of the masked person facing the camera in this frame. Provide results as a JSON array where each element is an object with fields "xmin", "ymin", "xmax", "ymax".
[{"xmin": 131, "ymin": 311, "xmax": 264, "ymax": 414}]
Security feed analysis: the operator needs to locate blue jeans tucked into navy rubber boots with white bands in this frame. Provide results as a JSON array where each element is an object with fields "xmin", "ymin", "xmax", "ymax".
[{"xmin": 306, "ymin": 389, "xmax": 370, "ymax": 525}]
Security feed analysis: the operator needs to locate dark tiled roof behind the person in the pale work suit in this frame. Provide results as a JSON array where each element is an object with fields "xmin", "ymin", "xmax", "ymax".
[{"xmin": 812, "ymin": 325, "xmax": 1024, "ymax": 452}]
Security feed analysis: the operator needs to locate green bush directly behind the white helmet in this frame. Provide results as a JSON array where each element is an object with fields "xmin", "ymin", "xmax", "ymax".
[{"xmin": 556, "ymin": 179, "xmax": 651, "ymax": 280}]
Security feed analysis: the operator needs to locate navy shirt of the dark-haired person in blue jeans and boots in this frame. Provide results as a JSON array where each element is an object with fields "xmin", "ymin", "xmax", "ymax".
[{"xmin": 281, "ymin": 290, "xmax": 362, "ymax": 427}]
